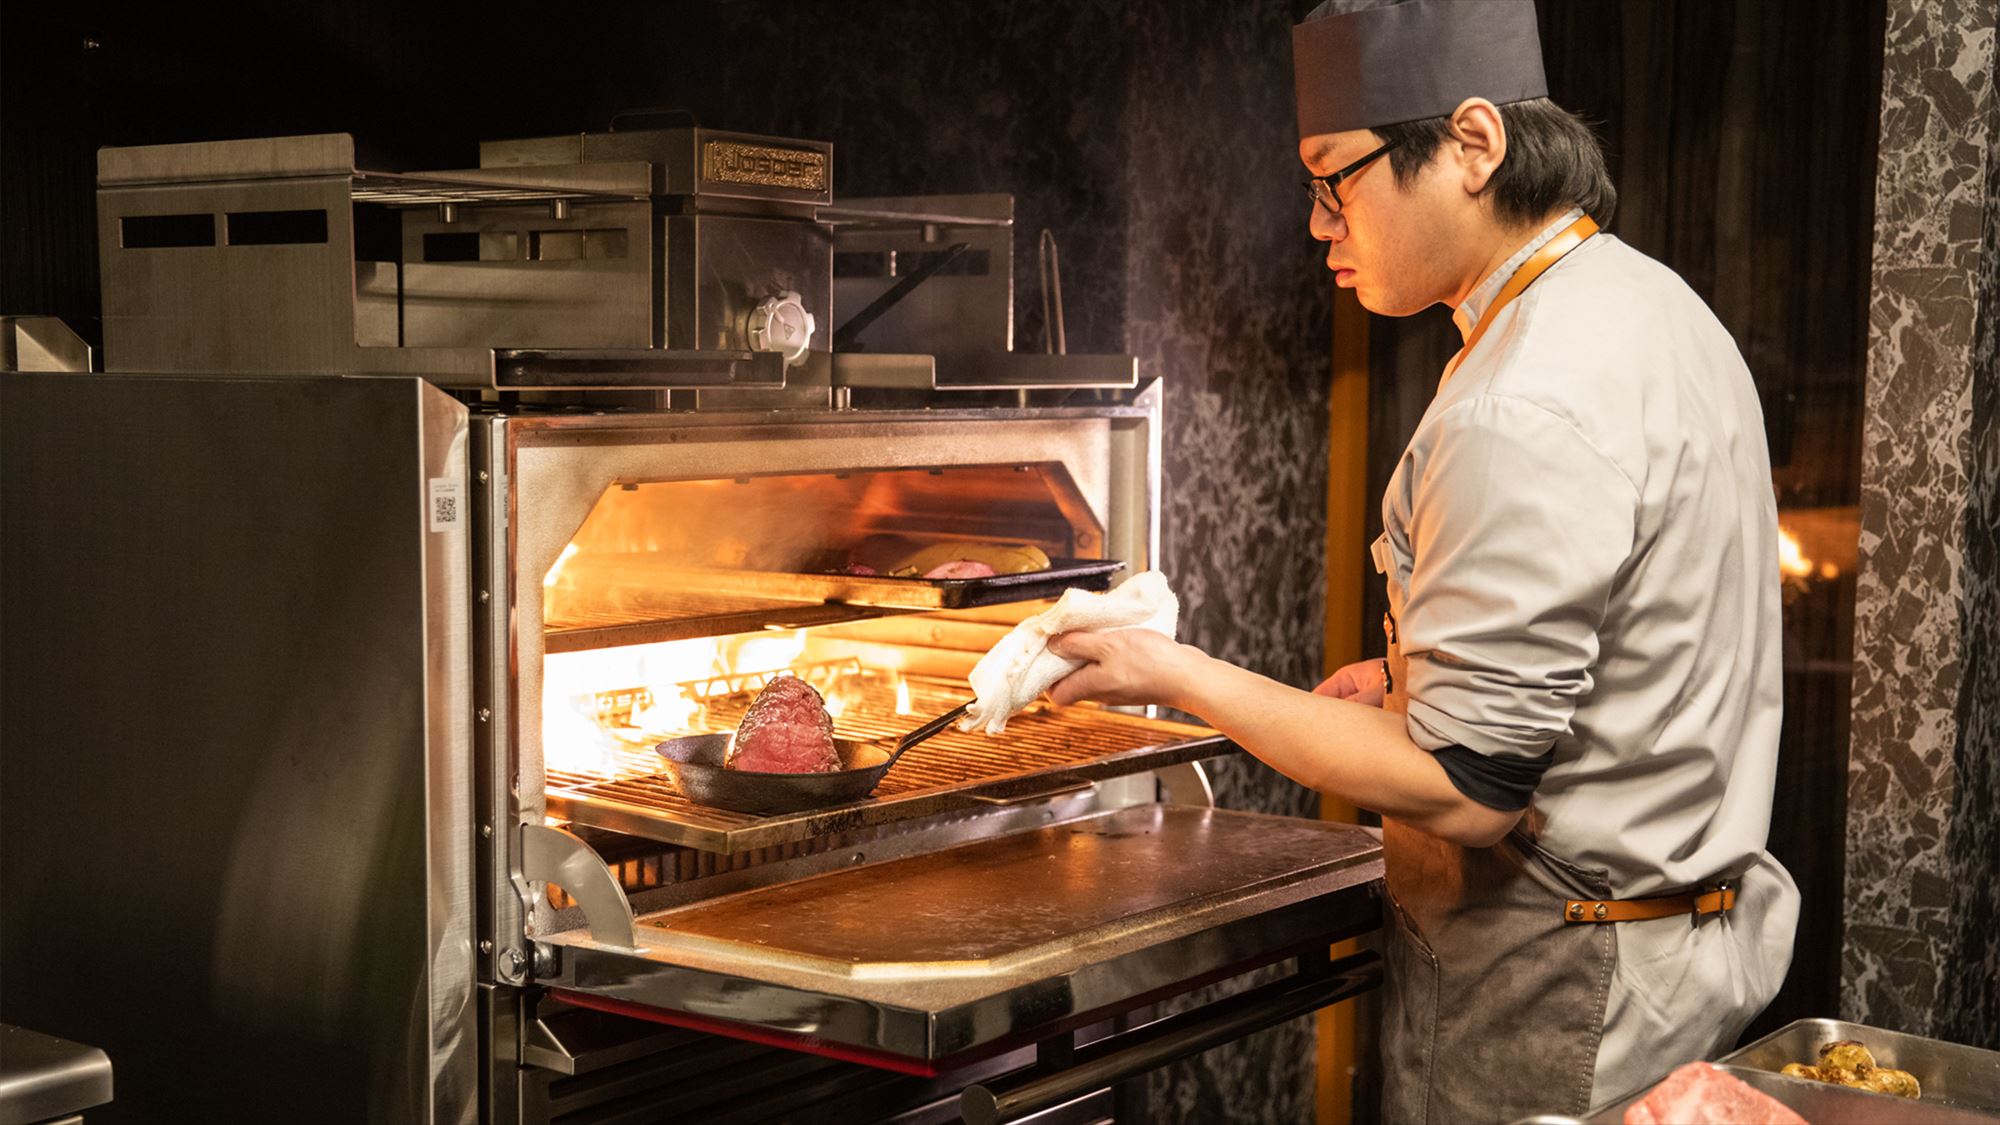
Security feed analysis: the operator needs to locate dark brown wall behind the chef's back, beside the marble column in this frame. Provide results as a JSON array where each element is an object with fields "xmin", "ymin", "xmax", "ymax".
[{"xmin": 1362, "ymin": 0, "xmax": 1882, "ymax": 1035}]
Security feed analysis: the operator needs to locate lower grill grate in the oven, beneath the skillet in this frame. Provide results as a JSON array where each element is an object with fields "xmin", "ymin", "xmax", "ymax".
[{"xmin": 546, "ymin": 673, "xmax": 1230, "ymax": 853}]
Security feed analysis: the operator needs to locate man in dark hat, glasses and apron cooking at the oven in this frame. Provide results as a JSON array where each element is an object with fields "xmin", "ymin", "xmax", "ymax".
[{"xmin": 1052, "ymin": 0, "xmax": 1798, "ymax": 1123}]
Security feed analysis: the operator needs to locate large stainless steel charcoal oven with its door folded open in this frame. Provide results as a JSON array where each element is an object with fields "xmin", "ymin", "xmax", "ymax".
[{"xmin": 0, "ymin": 130, "xmax": 1380, "ymax": 1123}]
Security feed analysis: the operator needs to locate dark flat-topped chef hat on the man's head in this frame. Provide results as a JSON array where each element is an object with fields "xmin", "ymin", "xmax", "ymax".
[{"xmin": 1292, "ymin": 0, "xmax": 1548, "ymax": 138}]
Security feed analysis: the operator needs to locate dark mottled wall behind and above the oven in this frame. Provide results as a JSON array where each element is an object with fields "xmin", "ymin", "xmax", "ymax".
[{"xmin": 0, "ymin": 0, "xmax": 1330, "ymax": 1121}]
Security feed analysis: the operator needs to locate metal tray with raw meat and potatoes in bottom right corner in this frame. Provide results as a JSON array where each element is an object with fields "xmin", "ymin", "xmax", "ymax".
[{"xmin": 1568, "ymin": 1019, "xmax": 2000, "ymax": 1125}]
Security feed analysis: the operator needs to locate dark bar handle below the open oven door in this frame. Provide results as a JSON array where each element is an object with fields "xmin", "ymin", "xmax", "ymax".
[{"xmin": 958, "ymin": 953, "xmax": 1382, "ymax": 1125}]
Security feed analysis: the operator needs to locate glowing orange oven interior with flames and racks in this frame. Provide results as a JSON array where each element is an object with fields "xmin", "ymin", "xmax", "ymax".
[{"xmin": 542, "ymin": 464, "xmax": 1212, "ymax": 860}]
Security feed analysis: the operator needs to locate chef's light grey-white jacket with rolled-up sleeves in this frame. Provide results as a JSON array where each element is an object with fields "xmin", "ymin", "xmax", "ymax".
[{"xmin": 1378, "ymin": 212, "xmax": 1798, "ymax": 1101}]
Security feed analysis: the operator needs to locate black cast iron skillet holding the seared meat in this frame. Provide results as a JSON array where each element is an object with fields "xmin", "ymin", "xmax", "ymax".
[{"xmin": 654, "ymin": 701, "xmax": 972, "ymax": 815}]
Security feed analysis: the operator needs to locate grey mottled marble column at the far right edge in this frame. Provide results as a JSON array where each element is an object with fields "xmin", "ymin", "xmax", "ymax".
[{"xmin": 1842, "ymin": 0, "xmax": 1996, "ymax": 1033}]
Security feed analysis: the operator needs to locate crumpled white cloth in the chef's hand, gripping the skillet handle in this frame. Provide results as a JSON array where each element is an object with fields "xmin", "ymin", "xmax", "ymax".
[{"xmin": 958, "ymin": 571, "xmax": 1180, "ymax": 735}]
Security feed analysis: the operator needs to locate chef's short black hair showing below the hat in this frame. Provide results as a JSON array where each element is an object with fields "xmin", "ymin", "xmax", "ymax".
[{"xmin": 1370, "ymin": 98, "xmax": 1618, "ymax": 226}]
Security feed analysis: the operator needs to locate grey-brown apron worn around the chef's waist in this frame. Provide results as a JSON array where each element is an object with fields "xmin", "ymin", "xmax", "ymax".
[{"xmin": 1382, "ymin": 608, "xmax": 1618, "ymax": 1125}]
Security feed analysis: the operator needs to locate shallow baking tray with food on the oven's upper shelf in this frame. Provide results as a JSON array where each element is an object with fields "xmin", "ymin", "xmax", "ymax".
[{"xmin": 640, "ymin": 558, "xmax": 1124, "ymax": 609}]
